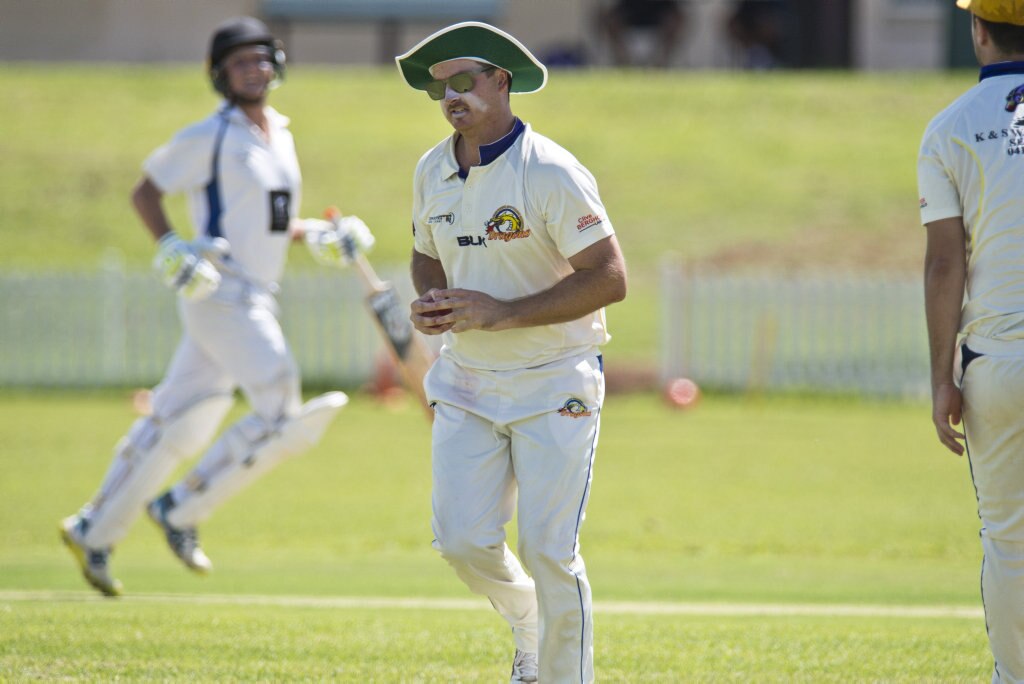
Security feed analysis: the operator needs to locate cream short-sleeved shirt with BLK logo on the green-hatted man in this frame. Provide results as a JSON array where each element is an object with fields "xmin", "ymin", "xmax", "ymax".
[{"xmin": 413, "ymin": 120, "xmax": 614, "ymax": 371}]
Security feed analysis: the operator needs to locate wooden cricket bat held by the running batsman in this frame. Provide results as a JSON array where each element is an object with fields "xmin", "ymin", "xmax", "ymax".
[{"xmin": 324, "ymin": 207, "xmax": 434, "ymax": 418}]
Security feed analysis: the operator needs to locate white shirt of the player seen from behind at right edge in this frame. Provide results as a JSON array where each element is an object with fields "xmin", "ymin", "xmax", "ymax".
[{"xmin": 918, "ymin": 62, "xmax": 1024, "ymax": 341}]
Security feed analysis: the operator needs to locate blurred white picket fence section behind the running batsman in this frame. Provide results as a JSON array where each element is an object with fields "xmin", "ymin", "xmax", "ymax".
[{"xmin": 0, "ymin": 268, "xmax": 413, "ymax": 387}]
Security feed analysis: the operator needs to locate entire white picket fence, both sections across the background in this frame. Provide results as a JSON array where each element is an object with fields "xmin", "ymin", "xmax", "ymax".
[{"xmin": 0, "ymin": 264, "xmax": 928, "ymax": 396}]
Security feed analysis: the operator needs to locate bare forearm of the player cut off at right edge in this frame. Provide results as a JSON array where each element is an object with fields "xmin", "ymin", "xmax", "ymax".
[{"xmin": 925, "ymin": 252, "xmax": 967, "ymax": 391}]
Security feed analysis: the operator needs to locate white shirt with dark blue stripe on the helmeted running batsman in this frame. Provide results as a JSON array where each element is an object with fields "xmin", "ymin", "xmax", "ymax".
[{"xmin": 142, "ymin": 103, "xmax": 302, "ymax": 286}]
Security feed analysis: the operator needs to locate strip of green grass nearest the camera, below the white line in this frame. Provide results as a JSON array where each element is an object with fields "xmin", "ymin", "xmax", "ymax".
[{"xmin": 0, "ymin": 599, "xmax": 989, "ymax": 682}]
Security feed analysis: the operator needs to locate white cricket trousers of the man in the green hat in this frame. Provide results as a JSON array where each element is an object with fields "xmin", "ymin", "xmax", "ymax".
[{"xmin": 424, "ymin": 352, "xmax": 604, "ymax": 684}]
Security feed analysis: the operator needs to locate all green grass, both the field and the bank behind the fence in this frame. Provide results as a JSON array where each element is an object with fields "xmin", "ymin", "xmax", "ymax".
[{"xmin": 0, "ymin": 63, "xmax": 991, "ymax": 682}]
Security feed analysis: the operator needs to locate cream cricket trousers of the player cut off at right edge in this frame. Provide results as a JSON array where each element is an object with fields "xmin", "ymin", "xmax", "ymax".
[{"xmin": 961, "ymin": 336, "xmax": 1024, "ymax": 684}]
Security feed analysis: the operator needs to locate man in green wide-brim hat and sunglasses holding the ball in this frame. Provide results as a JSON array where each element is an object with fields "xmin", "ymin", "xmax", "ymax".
[{"xmin": 397, "ymin": 22, "xmax": 626, "ymax": 683}]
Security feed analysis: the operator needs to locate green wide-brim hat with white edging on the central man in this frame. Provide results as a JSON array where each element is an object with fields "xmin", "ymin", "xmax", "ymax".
[{"xmin": 394, "ymin": 22, "xmax": 548, "ymax": 92}]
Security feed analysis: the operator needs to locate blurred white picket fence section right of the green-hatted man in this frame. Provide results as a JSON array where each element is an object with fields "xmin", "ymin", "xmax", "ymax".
[{"xmin": 660, "ymin": 262, "xmax": 929, "ymax": 397}]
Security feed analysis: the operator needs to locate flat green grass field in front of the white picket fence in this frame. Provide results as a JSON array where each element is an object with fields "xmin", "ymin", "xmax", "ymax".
[{"xmin": 0, "ymin": 392, "xmax": 989, "ymax": 682}]
